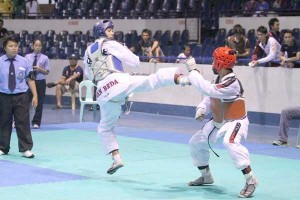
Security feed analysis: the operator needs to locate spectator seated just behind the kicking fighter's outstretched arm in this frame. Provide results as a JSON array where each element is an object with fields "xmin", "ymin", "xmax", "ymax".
[{"xmin": 130, "ymin": 29, "xmax": 164, "ymax": 62}]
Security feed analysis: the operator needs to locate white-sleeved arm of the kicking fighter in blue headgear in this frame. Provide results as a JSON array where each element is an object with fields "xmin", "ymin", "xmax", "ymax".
[{"xmin": 102, "ymin": 40, "xmax": 140, "ymax": 67}]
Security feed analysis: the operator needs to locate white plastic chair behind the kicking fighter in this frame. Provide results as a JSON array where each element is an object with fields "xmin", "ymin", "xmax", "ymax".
[{"xmin": 79, "ymin": 80, "xmax": 97, "ymax": 122}]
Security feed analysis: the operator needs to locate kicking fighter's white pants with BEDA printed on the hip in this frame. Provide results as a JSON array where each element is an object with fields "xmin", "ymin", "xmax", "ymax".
[{"xmin": 97, "ymin": 68, "xmax": 177, "ymax": 154}]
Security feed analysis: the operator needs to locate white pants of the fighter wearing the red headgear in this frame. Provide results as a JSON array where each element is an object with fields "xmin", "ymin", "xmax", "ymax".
[{"xmin": 189, "ymin": 117, "xmax": 250, "ymax": 170}]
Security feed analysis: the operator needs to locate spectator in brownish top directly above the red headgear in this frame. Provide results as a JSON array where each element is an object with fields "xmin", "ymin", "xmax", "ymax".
[{"xmin": 225, "ymin": 24, "xmax": 250, "ymax": 58}]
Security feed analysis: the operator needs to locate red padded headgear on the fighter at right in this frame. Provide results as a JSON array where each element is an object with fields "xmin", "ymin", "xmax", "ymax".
[{"xmin": 213, "ymin": 47, "xmax": 236, "ymax": 72}]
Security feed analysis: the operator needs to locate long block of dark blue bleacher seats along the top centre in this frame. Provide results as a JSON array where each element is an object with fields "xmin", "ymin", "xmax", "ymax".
[{"xmin": 46, "ymin": 0, "xmax": 206, "ymax": 19}]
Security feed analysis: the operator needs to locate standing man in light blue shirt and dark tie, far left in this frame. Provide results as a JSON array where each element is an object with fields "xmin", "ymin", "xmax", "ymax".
[{"xmin": 0, "ymin": 36, "xmax": 38, "ymax": 158}]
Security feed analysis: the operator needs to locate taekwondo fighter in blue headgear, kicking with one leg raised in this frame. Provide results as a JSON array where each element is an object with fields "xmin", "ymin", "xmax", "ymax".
[{"xmin": 84, "ymin": 19, "xmax": 189, "ymax": 174}]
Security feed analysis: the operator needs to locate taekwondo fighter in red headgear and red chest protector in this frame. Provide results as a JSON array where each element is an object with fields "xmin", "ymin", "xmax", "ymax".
[{"xmin": 179, "ymin": 47, "xmax": 258, "ymax": 198}]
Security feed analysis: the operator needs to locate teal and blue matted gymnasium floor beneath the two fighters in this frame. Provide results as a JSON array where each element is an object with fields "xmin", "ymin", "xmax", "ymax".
[{"xmin": 0, "ymin": 105, "xmax": 300, "ymax": 200}]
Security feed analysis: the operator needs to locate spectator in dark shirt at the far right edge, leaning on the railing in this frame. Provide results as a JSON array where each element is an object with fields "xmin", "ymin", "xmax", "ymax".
[{"xmin": 280, "ymin": 30, "xmax": 300, "ymax": 68}]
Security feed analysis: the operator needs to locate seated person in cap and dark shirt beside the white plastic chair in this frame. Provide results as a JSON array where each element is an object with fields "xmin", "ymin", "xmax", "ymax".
[{"xmin": 47, "ymin": 54, "xmax": 83, "ymax": 110}]
